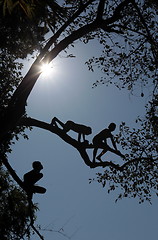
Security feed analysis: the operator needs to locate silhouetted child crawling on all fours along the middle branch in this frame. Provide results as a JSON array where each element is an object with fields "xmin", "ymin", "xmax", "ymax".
[{"xmin": 51, "ymin": 117, "xmax": 92, "ymax": 142}]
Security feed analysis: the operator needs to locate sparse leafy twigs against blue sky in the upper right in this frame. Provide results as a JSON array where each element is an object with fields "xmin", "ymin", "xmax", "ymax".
[{"xmin": 86, "ymin": 1, "xmax": 158, "ymax": 93}]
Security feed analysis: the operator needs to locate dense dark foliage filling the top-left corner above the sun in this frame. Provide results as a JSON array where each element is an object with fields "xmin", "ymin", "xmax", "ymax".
[{"xmin": 0, "ymin": 0, "xmax": 65, "ymax": 58}]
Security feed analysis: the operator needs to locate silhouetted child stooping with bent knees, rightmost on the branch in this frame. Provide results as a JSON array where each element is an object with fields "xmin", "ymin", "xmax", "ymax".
[{"xmin": 93, "ymin": 123, "xmax": 124, "ymax": 162}]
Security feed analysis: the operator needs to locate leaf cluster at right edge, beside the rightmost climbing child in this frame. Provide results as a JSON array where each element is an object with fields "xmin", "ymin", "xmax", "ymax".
[{"xmin": 93, "ymin": 96, "xmax": 158, "ymax": 203}]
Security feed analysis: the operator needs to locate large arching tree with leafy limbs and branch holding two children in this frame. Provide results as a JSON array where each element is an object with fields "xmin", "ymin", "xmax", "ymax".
[{"xmin": 0, "ymin": 0, "xmax": 158, "ymax": 238}]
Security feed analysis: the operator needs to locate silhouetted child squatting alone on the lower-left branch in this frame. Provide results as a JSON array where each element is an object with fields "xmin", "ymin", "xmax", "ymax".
[{"xmin": 24, "ymin": 161, "xmax": 46, "ymax": 198}]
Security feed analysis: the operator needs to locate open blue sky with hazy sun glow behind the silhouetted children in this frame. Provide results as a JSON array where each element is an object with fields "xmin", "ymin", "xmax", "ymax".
[{"xmin": 10, "ymin": 40, "xmax": 158, "ymax": 240}]
